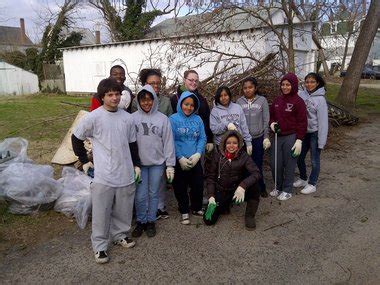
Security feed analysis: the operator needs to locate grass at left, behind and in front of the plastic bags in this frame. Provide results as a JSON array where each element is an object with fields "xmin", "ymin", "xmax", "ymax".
[{"xmin": 0, "ymin": 94, "xmax": 90, "ymax": 251}]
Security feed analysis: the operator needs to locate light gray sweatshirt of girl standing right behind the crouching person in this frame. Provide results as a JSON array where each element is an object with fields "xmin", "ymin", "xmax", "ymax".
[{"xmin": 210, "ymin": 102, "xmax": 252, "ymax": 146}]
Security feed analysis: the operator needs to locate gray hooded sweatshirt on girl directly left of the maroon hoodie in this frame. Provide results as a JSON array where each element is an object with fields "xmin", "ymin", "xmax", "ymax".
[{"xmin": 236, "ymin": 95, "xmax": 269, "ymax": 139}]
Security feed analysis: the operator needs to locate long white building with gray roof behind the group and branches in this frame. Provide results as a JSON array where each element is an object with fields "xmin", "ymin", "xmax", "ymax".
[{"xmin": 63, "ymin": 6, "xmax": 315, "ymax": 93}]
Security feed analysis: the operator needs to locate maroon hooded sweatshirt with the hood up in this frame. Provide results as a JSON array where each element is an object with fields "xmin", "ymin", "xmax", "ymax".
[{"xmin": 269, "ymin": 73, "xmax": 307, "ymax": 140}]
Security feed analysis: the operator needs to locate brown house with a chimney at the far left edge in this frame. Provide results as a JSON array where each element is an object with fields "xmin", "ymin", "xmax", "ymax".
[{"xmin": 0, "ymin": 18, "xmax": 35, "ymax": 52}]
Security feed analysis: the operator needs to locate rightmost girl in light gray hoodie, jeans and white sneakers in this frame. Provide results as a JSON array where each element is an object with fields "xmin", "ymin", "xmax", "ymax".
[{"xmin": 293, "ymin": 72, "xmax": 329, "ymax": 194}]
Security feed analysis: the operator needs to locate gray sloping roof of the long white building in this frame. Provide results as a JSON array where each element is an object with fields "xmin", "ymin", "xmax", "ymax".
[{"xmin": 145, "ymin": 7, "xmax": 282, "ymax": 38}]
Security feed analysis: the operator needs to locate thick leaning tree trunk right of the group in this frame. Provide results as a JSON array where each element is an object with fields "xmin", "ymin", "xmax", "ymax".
[{"xmin": 337, "ymin": 0, "xmax": 380, "ymax": 108}]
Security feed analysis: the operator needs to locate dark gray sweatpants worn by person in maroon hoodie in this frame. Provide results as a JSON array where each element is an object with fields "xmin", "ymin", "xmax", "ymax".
[{"xmin": 270, "ymin": 134, "xmax": 297, "ymax": 193}]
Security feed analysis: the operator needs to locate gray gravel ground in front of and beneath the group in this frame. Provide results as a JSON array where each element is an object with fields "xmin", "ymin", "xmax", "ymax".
[{"xmin": 0, "ymin": 117, "xmax": 380, "ymax": 284}]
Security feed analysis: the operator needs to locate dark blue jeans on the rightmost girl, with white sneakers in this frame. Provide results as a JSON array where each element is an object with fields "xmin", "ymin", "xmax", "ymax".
[{"xmin": 297, "ymin": 131, "xmax": 321, "ymax": 186}]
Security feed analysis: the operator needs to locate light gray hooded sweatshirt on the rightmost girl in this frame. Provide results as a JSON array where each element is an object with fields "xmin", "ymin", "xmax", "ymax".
[{"xmin": 298, "ymin": 87, "xmax": 329, "ymax": 149}]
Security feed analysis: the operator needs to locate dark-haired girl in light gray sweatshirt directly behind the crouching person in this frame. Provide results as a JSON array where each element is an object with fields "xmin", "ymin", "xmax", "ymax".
[{"xmin": 210, "ymin": 86, "xmax": 252, "ymax": 155}]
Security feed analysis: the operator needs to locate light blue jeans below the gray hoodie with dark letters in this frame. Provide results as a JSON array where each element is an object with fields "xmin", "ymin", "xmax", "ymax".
[{"xmin": 135, "ymin": 164, "xmax": 165, "ymax": 223}]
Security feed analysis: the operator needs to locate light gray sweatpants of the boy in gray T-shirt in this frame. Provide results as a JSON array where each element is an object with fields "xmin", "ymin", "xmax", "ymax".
[{"xmin": 91, "ymin": 183, "xmax": 136, "ymax": 252}]
